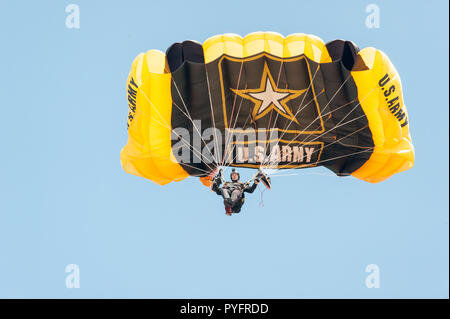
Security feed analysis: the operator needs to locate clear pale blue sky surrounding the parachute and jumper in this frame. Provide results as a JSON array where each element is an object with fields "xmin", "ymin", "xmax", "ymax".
[{"xmin": 0, "ymin": 0, "xmax": 449, "ymax": 298}]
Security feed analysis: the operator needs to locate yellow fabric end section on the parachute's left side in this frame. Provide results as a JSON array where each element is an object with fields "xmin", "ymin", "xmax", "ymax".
[{"xmin": 120, "ymin": 50, "xmax": 189, "ymax": 185}]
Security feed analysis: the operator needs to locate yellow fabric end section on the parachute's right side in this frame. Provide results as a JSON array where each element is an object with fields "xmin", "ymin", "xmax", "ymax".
[{"xmin": 352, "ymin": 48, "xmax": 414, "ymax": 183}]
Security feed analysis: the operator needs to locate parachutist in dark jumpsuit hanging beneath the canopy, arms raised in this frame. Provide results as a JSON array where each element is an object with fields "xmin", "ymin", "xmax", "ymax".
[{"xmin": 211, "ymin": 168, "xmax": 270, "ymax": 216}]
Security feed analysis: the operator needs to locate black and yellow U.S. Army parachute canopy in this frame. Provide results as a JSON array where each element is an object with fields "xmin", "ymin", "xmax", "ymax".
[{"xmin": 120, "ymin": 32, "xmax": 414, "ymax": 185}]
